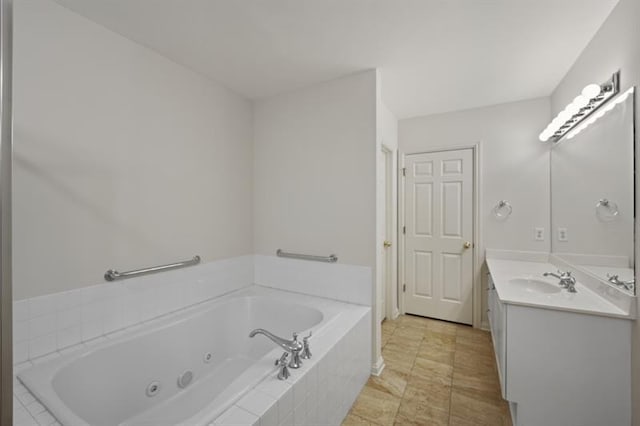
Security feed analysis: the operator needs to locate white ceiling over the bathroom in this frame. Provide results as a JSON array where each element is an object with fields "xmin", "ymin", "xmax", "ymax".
[{"xmin": 56, "ymin": 0, "xmax": 617, "ymax": 118}]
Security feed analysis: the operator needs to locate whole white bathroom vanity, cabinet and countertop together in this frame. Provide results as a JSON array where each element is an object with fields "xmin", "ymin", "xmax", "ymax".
[{"xmin": 487, "ymin": 251, "xmax": 635, "ymax": 426}]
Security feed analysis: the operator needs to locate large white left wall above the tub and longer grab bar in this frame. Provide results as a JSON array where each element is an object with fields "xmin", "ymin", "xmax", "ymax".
[{"xmin": 13, "ymin": 0, "xmax": 252, "ymax": 299}]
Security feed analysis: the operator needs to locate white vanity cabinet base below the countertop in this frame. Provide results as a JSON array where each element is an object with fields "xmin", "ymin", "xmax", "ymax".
[{"xmin": 487, "ymin": 276, "xmax": 631, "ymax": 426}]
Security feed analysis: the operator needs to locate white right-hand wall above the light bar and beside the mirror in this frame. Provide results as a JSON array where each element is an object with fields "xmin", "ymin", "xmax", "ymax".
[{"xmin": 551, "ymin": 0, "xmax": 640, "ymax": 425}]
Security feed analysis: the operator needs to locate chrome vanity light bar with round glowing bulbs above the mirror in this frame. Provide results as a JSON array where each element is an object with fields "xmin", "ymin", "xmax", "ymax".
[{"xmin": 539, "ymin": 71, "xmax": 620, "ymax": 142}]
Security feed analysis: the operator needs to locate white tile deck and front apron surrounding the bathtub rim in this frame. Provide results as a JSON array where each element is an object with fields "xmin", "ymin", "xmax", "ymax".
[{"xmin": 14, "ymin": 286, "xmax": 371, "ymax": 426}]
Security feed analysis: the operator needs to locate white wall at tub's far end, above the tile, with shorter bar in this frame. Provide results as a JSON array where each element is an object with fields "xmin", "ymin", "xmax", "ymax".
[{"xmin": 253, "ymin": 71, "xmax": 380, "ymax": 362}]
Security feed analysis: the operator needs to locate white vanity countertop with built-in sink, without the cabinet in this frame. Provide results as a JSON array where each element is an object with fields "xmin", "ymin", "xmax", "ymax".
[{"xmin": 487, "ymin": 259, "xmax": 631, "ymax": 319}]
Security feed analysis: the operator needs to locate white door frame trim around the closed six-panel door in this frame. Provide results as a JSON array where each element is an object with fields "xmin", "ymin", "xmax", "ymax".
[{"xmin": 398, "ymin": 145, "xmax": 484, "ymax": 328}]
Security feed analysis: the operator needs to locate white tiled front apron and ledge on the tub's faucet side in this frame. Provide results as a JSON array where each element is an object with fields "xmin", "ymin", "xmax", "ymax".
[{"xmin": 212, "ymin": 308, "xmax": 371, "ymax": 426}]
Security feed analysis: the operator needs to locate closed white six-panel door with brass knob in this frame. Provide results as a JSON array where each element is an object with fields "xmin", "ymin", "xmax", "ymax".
[{"xmin": 404, "ymin": 149, "xmax": 474, "ymax": 324}]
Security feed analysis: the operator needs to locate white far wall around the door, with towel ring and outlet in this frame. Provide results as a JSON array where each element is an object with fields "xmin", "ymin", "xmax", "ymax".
[{"xmin": 398, "ymin": 98, "xmax": 550, "ymax": 326}]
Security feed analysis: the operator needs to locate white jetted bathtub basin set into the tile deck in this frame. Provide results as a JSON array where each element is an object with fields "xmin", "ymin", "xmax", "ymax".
[{"xmin": 19, "ymin": 286, "xmax": 353, "ymax": 426}]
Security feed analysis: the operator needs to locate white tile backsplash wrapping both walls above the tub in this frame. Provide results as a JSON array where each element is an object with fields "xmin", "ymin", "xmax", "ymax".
[{"xmin": 13, "ymin": 255, "xmax": 373, "ymax": 364}]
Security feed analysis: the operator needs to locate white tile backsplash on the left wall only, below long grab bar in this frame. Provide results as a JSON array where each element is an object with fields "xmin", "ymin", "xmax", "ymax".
[{"xmin": 13, "ymin": 256, "xmax": 253, "ymax": 364}]
